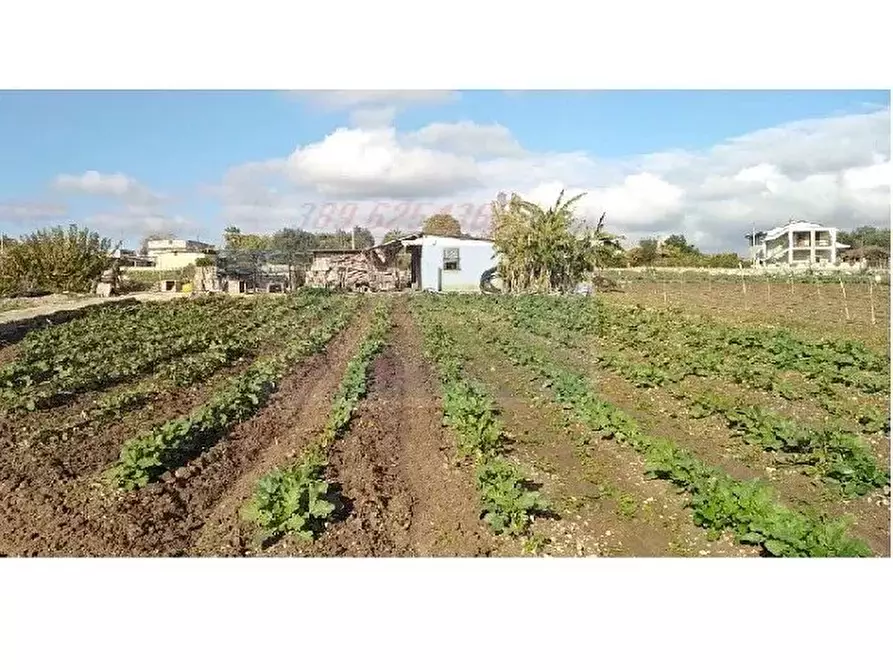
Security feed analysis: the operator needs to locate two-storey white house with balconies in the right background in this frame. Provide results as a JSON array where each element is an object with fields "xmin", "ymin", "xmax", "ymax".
[{"xmin": 746, "ymin": 221, "xmax": 849, "ymax": 266}]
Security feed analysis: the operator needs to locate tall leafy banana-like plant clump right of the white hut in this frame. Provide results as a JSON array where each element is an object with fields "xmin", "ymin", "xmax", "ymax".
[{"xmin": 491, "ymin": 191, "xmax": 606, "ymax": 292}]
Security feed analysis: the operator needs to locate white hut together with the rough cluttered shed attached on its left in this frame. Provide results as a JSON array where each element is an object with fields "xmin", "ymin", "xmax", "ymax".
[{"xmin": 305, "ymin": 233, "xmax": 496, "ymax": 293}]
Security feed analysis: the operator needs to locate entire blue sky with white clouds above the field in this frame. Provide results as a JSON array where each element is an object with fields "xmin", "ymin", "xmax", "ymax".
[{"xmin": 0, "ymin": 91, "xmax": 891, "ymax": 252}]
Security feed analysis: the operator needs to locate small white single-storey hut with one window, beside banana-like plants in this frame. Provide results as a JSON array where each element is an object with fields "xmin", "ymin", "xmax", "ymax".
[{"xmin": 399, "ymin": 233, "xmax": 496, "ymax": 293}]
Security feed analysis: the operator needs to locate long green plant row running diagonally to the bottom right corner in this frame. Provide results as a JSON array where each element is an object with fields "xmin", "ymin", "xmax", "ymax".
[{"xmin": 460, "ymin": 304, "xmax": 870, "ymax": 556}]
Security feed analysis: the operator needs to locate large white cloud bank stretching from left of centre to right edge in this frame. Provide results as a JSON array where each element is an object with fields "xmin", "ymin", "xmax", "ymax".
[{"xmin": 209, "ymin": 108, "xmax": 891, "ymax": 250}]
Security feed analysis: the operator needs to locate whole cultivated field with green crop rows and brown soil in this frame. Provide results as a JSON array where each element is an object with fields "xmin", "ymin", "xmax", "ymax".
[{"xmin": 0, "ymin": 285, "xmax": 890, "ymax": 557}]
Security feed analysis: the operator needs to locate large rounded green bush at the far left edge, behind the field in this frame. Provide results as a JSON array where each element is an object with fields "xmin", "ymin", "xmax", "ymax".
[{"xmin": 0, "ymin": 224, "xmax": 117, "ymax": 295}]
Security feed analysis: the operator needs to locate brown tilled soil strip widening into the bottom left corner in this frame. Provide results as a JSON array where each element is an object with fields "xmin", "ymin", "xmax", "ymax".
[{"xmin": 0, "ymin": 315, "xmax": 362, "ymax": 556}]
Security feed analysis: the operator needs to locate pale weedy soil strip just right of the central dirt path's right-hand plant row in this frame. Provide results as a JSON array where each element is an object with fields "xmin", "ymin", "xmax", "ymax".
[{"xmin": 446, "ymin": 318, "xmax": 755, "ymax": 557}]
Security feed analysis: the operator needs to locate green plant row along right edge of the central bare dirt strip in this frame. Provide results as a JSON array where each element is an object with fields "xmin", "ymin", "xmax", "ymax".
[{"xmin": 413, "ymin": 297, "xmax": 549, "ymax": 535}]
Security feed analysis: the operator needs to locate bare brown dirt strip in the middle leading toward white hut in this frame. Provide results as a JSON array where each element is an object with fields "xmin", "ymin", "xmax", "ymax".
[{"xmin": 270, "ymin": 299, "xmax": 499, "ymax": 556}]
